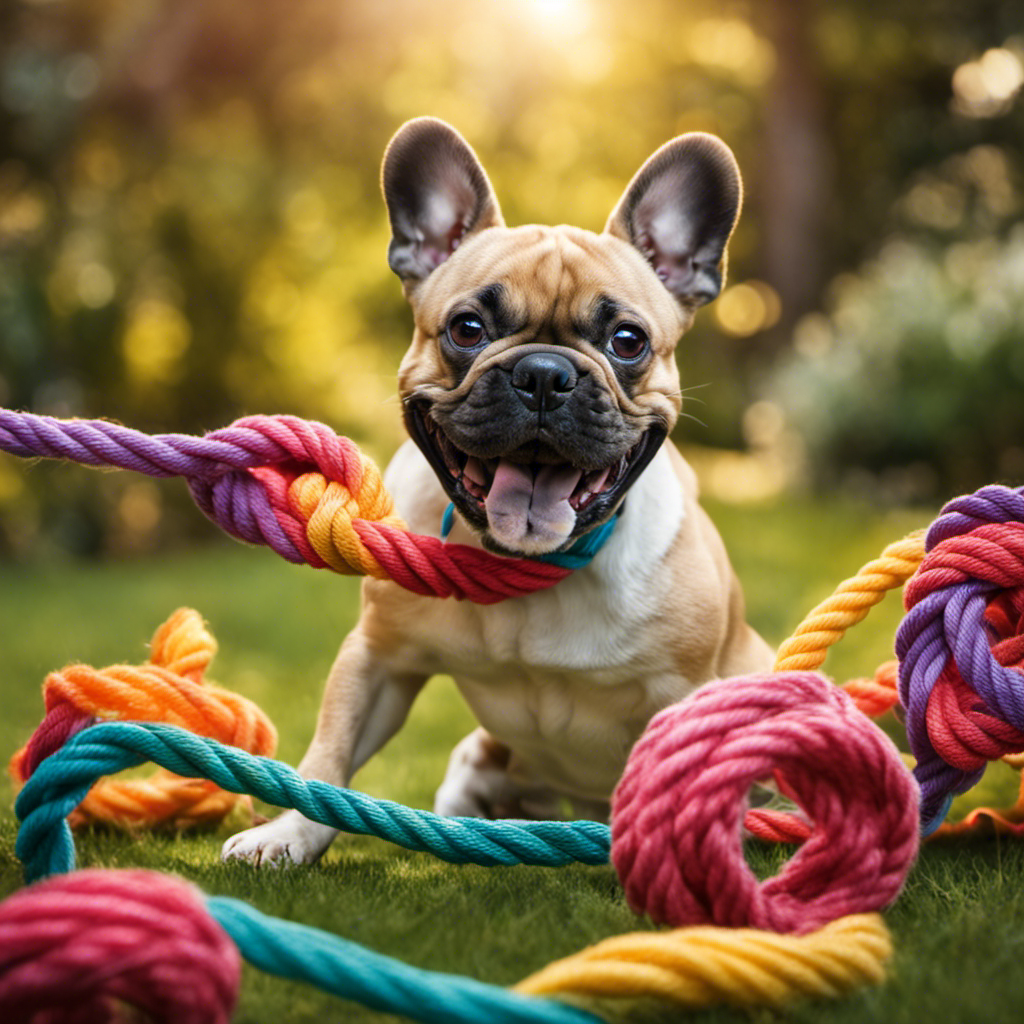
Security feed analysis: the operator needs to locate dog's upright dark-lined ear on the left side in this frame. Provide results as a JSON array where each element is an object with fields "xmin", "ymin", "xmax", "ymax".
[{"xmin": 381, "ymin": 118, "xmax": 504, "ymax": 292}]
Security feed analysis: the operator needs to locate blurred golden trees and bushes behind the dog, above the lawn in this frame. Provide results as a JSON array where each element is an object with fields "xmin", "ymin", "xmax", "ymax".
[{"xmin": 0, "ymin": 0, "xmax": 1024, "ymax": 560}]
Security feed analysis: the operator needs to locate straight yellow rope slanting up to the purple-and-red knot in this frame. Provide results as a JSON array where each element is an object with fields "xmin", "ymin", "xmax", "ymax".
[{"xmin": 775, "ymin": 529, "xmax": 925, "ymax": 672}]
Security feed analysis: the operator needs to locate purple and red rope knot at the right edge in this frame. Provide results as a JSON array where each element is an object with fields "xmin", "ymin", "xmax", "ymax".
[{"xmin": 896, "ymin": 486, "xmax": 1024, "ymax": 834}]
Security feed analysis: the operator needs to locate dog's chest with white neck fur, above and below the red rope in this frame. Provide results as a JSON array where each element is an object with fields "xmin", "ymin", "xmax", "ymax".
[{"xmin": 378, "ymin": 445, "xmax": 685, "ymax": 799}]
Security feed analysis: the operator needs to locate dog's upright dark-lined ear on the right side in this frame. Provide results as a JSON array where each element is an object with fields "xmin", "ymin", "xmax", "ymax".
[{"xmin": 604, "ymin": 132, "xmax": 743, "ymax": 307}]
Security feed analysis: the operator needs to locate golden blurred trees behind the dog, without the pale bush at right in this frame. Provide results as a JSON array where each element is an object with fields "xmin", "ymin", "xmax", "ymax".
[{"xmin": 0, "ymin": 0, "xmax": 1022, "ymax": 557}]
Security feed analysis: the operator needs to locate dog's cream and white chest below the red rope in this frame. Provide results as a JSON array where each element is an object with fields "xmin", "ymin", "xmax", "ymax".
[{"xmin": 393, "ymin": 585, "xmax": 689, "ymax": 799}]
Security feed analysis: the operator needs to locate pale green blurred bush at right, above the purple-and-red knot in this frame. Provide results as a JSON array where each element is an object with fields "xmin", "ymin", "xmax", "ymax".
[{"xmin": 773, "ymin": 146, "xmax": 1024, "ymax": 500}]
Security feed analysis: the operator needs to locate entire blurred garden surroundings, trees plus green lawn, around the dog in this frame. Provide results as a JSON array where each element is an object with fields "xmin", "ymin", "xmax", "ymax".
[{"xmin": 0, "ymin": 12, "xmax": 1024, "ymax": 1024}]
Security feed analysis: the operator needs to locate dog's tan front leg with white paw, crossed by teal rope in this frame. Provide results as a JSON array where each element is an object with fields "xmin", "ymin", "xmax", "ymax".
[{"xmin": 221, "ymin": 626, "xmax": 427, "ymax": 865}]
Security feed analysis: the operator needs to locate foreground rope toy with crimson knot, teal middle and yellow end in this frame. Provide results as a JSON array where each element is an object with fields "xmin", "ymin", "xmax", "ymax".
[{"xmin": 0, "ymin": 869, "xmax": 892, "ymax": 1024}]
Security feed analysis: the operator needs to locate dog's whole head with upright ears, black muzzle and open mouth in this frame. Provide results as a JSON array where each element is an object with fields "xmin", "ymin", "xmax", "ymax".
[{"xmin": 383, "ymin": 118, "xmax": 741, "ymax": 555}]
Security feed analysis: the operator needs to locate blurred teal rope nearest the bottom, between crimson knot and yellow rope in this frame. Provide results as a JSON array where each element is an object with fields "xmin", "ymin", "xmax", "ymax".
[{"xmin": 207, "ymin": 896, "xmax": 601, "ymax": 1024}]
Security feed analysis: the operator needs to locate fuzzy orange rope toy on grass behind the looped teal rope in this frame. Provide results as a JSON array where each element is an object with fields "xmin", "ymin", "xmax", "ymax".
[{"xmin": 9, "ymin": 608, "xmax": 278, "ymax": 828}]
